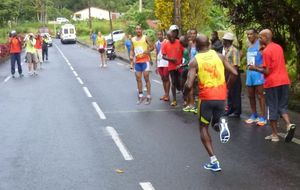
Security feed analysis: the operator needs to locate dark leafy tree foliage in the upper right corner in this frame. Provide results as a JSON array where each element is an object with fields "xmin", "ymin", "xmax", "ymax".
[{"xmin": 215, "ymin": 0, "xmax": 300, "ymax": 77}]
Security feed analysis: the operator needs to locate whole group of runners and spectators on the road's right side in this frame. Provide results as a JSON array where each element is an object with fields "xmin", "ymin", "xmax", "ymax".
[{"xmin": 130, "ymin": 25, "xmax": 296, "ymax": 171}]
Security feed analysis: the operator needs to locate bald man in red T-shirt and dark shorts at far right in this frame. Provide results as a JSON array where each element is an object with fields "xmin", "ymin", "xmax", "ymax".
[{"xmin": 249, "ymin": 29, "xmax": 296, "ymax": 142}]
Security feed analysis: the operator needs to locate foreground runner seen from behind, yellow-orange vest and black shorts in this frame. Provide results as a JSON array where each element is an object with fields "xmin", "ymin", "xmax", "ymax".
[{"xmin": 184, "ymin": 34, "xmax": 238, "ymax": 171}]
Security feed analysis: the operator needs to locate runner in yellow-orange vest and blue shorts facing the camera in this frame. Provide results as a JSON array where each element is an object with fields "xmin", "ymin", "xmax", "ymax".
[{"xmin": 130, "ymin": 25, "xmax": 154, "ymax": 105}]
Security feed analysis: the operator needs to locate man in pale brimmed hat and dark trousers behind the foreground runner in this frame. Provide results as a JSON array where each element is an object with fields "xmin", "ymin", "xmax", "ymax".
[{"xmin": 222, "ymin": 32, "xmax": 242, "ymax": 118}]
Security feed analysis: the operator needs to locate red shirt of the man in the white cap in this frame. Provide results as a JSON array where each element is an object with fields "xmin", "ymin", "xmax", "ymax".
[{"xmin": 162, "ymin": 39, "xmax": 184, "ymax": 71}]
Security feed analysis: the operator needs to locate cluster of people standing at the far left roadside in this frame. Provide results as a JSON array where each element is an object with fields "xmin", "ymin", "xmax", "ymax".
[{"xmin": 9, "ymin": 31, "xmax": 48, "ymax": 78}]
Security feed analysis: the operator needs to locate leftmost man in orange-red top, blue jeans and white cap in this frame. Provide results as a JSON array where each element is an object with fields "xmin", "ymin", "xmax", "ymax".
[{"xmin": 9, "ymin": 30, "xmax": 23, "ymax": 78}]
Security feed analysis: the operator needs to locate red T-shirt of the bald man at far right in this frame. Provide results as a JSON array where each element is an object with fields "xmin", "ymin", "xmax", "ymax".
[{"xmin": 262, "ymin": 42, "xmax": 290, "ymax": 88}]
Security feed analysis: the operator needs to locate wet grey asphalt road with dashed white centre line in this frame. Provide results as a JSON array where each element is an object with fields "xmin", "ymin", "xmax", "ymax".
[{"xmin": 0, "ymin": 41, "xmax": 300, "ymax": 190}]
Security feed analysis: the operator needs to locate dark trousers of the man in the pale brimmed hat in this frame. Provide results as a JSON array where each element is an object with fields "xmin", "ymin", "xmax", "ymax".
[{"xmin": 227, "ymin": 74, "xmax": 242, "ymax": 115}]
